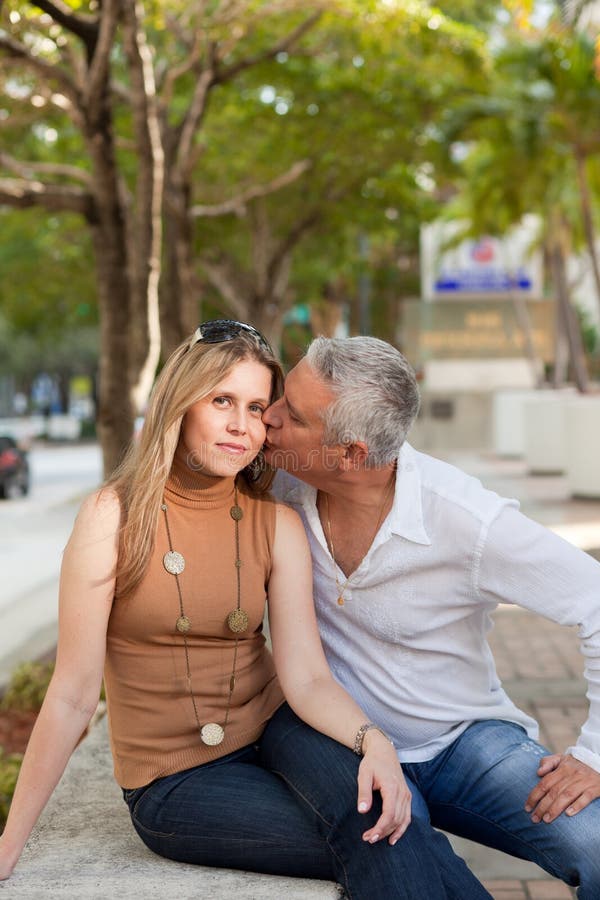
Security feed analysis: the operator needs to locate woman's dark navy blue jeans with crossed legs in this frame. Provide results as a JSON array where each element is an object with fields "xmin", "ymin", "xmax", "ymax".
[{"xmin": 124, "ymin": 706, "xmax": 490, "ymax": 900}]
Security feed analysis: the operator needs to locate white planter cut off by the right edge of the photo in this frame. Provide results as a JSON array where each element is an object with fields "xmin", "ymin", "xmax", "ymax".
[{"xmin": 565, "ymin": 394, "xmax": 600, "ymax": 497}]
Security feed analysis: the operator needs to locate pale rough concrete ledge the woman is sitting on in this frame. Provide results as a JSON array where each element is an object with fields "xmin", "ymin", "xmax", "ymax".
[{"xmin": 0, "ymin": 717, "xmax": 341, "ymax": 900}]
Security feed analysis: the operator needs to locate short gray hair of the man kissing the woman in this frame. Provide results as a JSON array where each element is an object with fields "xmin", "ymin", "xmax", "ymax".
[{"xmin": 306, "ymin": 337, "xmax": 419, "ymax": 466}]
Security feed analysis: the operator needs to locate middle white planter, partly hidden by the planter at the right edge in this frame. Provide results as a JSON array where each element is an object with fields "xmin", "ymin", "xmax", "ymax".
[{"xmin": 523, "ymin": 388, "xmax": 574, "ymax": 475}]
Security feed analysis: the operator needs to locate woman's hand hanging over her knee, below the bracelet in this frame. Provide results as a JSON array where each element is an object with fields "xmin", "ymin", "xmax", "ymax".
[{"xmin": 358, "ymin": 728, "xmax": 412, "ymax": 846}]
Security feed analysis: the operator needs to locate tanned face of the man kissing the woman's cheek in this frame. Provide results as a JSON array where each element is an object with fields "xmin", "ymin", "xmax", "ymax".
[{"xmin": 263, "ymin": 359, "xmax": 337, "ymax": 483}]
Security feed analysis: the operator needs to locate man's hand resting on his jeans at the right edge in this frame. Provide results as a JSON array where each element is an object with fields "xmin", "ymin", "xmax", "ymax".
[{"xmin": 525, "ymin": 753, "xmax": 600, "ymax": 822}]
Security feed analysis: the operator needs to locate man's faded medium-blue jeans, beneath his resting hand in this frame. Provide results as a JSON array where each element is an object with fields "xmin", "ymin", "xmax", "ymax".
[{"xmin": 402, "ymin": 720, "xmax": 600, "ymax": 900}]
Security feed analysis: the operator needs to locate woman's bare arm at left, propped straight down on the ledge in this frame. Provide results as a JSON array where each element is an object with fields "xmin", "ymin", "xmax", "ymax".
[{"xmin": 0, "ymin": 491, "xmax": 120, "ymax": 880}]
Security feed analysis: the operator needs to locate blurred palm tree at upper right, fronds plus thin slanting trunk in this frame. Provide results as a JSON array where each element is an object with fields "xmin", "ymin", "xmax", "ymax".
[{"xmin": 446, "ymin": 28, "xmax": 600, "ymax": 391}]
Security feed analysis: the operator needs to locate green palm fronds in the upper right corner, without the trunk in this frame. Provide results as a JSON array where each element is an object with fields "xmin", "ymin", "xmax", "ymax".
[{"xmin": 444, "ymin": 17, "xmax": 600, "ymax": 255}]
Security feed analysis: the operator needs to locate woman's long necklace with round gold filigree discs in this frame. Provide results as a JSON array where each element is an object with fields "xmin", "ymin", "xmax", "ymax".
[{"xmin": 161, "ymin": 484, "xmax": 249, "ymax": 747}]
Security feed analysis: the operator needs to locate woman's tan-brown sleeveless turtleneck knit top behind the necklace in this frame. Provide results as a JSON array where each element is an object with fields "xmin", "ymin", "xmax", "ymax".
[{"xmin": 105, "ymin": 459, "xmax": 283, "ymax": 788}]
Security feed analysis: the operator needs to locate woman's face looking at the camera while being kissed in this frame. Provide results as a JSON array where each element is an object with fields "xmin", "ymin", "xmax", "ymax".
[{"xmin": 180, "ymin": 359, "xmax": 272, "ymax": 476}]
